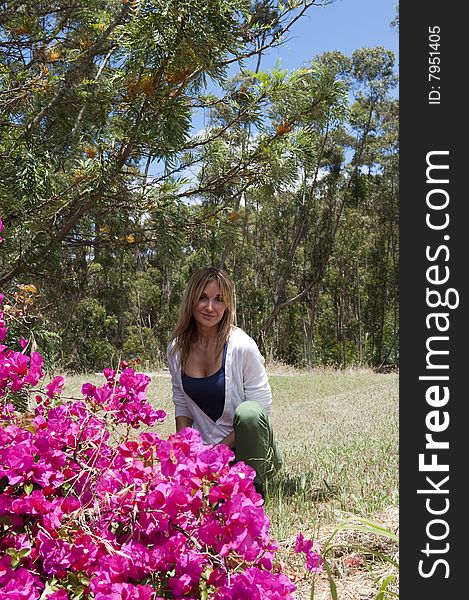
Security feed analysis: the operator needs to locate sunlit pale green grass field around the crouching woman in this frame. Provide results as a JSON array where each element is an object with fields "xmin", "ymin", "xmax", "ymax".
[{"xmin": 65, "ymin": 369, "xmax": 399, "ymax": 600}]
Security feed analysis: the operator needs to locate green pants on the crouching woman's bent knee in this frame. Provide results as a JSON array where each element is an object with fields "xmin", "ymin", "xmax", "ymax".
[{"xmin": 233, "ymin": 400, "xmax": 283, "ymax": 488}]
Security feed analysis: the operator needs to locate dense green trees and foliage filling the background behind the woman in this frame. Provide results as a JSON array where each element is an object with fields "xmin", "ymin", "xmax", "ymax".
[{"xmin": 0, "ymin": 0, "xmax": 399, "ymax": 372}]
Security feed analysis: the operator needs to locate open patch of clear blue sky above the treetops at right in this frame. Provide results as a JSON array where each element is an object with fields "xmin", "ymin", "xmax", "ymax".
[{"xmin": 254, "ymin": 0, "xmax": 399, "ymax": 70}]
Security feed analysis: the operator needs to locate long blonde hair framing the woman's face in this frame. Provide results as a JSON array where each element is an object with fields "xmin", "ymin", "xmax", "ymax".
[{"xmin": 171, "ymin": 267, "xmax": 236, "ymax": 370}]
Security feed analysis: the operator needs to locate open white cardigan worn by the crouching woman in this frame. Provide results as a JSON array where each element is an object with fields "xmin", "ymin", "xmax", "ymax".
[{"xmin": 167, "ymin": 327, "xmax": 272, "ymax": 444}]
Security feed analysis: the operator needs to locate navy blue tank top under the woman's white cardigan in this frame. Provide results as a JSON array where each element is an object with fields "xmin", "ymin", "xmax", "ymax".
[{"xmin": 182, "ymin": 342, "xmax": 227, "ymax": 423}]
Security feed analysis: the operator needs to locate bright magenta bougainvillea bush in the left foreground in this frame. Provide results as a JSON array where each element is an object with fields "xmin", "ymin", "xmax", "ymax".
[{"xmin": 0, "ymin": 295, "xmax": 300, "ymax": 600}]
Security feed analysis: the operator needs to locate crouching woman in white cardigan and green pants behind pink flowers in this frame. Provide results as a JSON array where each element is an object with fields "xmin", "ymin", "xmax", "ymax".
[{"xmin": 168, "ymin": 267, "xmax": 282, "ymax": 493}]
